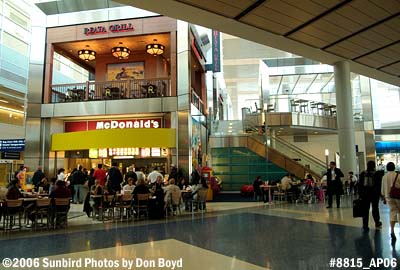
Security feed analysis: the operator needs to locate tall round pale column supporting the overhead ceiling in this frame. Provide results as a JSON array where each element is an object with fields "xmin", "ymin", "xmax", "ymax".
[{"xmin": 334, "ymin": 61, "xmax": 357, "ymax": 175}]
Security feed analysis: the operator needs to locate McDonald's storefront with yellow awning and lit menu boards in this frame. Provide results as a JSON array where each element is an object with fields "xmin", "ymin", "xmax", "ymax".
[{"xmin": 52, "ymin": 115, "xmax": 175, "ymax": 173}]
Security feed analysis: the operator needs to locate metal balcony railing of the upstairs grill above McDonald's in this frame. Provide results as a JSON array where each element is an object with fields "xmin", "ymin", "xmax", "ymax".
[{"xmin": 51, "ymin": 78, "xmax": 171, "ymax": 103}]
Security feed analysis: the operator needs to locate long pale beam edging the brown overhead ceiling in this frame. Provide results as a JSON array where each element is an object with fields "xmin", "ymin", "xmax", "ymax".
[{"xmin": 115, "ymin": 0, "xmax": 400, "ymax": 86}]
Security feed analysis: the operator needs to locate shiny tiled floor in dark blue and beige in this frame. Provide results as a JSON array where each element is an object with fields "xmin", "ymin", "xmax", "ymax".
[{"xmin": 0, "ymin": 197, "xmax": 400, "ymax": 270}]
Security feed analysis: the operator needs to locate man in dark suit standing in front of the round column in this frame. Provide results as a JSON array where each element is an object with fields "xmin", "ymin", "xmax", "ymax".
[{"xmin": 326, "ymin": 161, "xmax": 344, "ymax": 208}]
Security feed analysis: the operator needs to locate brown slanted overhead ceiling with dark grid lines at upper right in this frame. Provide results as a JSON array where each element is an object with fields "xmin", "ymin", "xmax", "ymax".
[{"xmin": 114, "ymin": 0, "xmax": 400, "ymax": 86}]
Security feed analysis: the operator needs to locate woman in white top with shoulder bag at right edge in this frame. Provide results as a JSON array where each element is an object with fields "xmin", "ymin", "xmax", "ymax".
[{"xmin": 382, "ymin": 162, "xmax": 400, "ymax": 241}]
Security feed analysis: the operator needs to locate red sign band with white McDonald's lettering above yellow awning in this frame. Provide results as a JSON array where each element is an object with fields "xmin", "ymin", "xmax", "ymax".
[{"xmin": 64, "ymin": 118, "xmax": 162, "ymax": 132}]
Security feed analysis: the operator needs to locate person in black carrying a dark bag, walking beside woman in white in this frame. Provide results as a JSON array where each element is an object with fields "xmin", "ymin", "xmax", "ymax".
[{"xmin": 358, "ymin": 160, "xmax": 382, "ymax": 231}]
